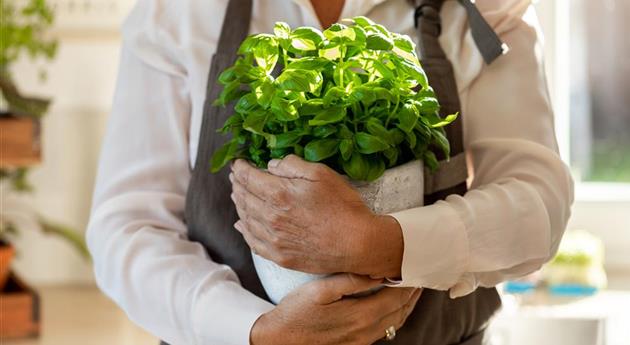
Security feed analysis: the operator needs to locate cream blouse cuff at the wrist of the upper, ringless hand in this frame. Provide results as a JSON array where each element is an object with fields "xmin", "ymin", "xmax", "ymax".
[{"xmin": 390, "ymin": 201, "xmax": 469, "ymax": 290}]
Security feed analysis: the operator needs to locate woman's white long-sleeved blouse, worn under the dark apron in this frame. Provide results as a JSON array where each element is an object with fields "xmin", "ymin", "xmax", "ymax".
[{"xmin": 87, "ymin": 0, "xmax": 573, "ymax": 345}]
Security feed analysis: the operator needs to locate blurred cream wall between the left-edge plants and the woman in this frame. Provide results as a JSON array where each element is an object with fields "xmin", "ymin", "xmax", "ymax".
[{"xmin": 14, "ymin": 33, "xmax": 120, "ymax": 284}]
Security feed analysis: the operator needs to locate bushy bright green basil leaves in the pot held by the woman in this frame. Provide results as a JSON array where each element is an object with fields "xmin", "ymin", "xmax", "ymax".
[{"xmin": 211, "ymin": 17, "xmax": 457, "ymax": 181}]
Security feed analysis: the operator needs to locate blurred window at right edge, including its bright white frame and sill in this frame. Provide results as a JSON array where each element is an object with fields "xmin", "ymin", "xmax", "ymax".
[{"xmin": 537, "ymin": 0, "xmax": 630, "ymax": 201}]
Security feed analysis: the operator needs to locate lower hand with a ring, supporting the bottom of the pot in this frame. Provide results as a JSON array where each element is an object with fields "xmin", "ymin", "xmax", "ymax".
[{"xmin": 250, "ymin": 273, "xmax": 422, "ymax": 345}]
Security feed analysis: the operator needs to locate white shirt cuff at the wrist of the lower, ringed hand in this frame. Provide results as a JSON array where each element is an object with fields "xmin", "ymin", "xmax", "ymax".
[{"xmin": 193, "ymin": 281, "xmax": 274, "ymax": 345}]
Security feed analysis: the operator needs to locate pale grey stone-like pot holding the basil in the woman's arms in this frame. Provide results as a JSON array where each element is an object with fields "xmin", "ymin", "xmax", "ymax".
[{"xmin": 252, "ymin": 160, "xmax": 424, "ymax": 304}]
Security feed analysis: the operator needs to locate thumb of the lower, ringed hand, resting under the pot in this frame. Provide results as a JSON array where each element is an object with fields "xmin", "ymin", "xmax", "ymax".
[{"xmin": 308, "ymin": 273, "xmax": 383, "ymax": 304}]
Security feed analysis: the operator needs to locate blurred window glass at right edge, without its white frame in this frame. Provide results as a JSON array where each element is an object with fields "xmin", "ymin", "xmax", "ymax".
[{"xmin": 568, "ymin": 0, "xmax": 630, "ymax": 183}]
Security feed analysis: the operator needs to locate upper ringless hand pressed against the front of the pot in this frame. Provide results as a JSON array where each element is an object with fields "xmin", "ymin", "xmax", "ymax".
[{"xmin": 230, "ymin": 155, "xmax": 403, "ymax": 278}]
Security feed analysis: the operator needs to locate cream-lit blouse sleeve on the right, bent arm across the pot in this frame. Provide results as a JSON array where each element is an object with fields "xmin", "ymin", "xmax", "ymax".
[{"xmin": 392, "ymin": 0, "xmax": 573, "ymax": 297}]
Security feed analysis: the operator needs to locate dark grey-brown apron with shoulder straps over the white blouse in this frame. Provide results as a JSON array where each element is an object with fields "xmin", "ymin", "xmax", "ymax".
[{"xmin": 172, "ymin": 0, "xmax": 501, "ymax": 345}]
